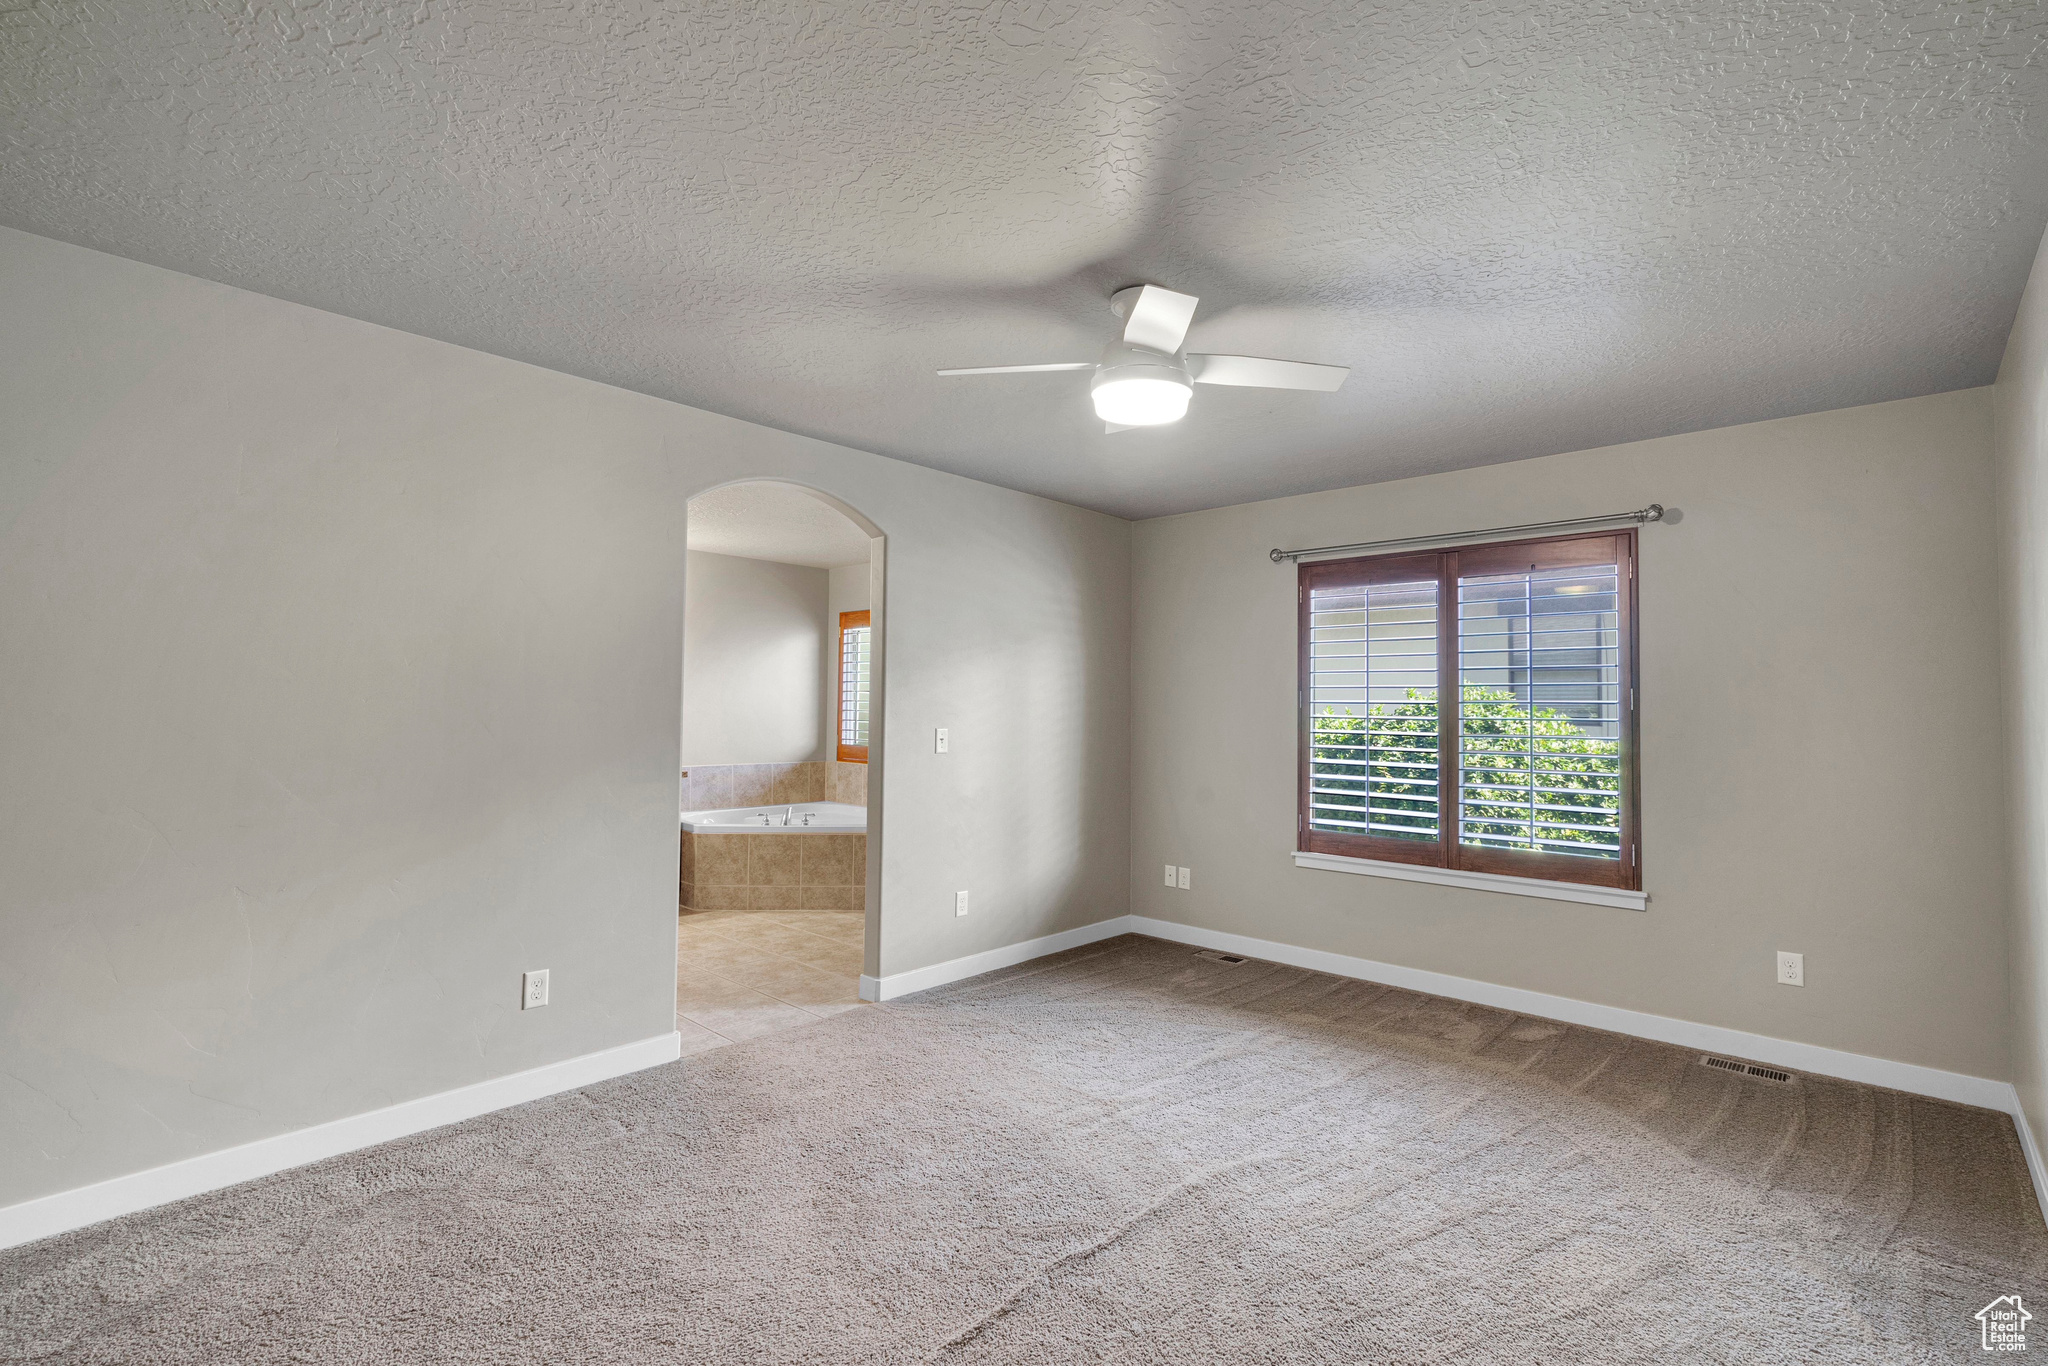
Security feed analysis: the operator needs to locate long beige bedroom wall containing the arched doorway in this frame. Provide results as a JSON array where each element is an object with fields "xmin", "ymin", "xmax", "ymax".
[{"xmin": 0, "ymin": 229, "xmax": 1130, "ymax": 1204}]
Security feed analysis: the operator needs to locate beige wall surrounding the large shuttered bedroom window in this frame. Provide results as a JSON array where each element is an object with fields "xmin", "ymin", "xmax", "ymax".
[{"xmin": 1130, "ymin": 389, "xmax": 2007, "ymax": 1077}]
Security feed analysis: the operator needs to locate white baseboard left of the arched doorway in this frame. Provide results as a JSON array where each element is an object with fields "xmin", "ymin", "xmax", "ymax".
[{"xmin": 0, "ymin": 1032, "xmax": 682, "ymax": 1247}]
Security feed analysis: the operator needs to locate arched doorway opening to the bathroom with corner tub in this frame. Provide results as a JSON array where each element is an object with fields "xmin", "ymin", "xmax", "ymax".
[{"xmin": 676, "ymin": 479, "xmax": 885, "ymax": 1053}]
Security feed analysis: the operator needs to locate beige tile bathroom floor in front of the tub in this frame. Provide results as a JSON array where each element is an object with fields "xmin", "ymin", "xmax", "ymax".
[{"xmin": 676, "ymin": 911, "xmax": 866, "ymax": 1053}]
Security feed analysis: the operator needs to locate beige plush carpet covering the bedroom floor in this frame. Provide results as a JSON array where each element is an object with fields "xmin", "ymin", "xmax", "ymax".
[{"xmin": 0, "ymin": 938, "xmax": 2048, "ymax": 1366}]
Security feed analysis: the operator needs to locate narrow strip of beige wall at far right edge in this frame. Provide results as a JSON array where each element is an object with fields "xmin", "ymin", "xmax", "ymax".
[{"xmin": 1993, "ymin": 227, "xmax": 2048, "ymax": 1135}]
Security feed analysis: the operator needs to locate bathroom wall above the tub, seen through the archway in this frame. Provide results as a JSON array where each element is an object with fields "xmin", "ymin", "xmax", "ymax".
[{"xmin": 682, "ymin": 551, "xmax": 831, "ymax": 766}]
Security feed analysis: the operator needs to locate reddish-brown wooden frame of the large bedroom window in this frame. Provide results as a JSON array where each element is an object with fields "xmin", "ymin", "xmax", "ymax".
[{"xmin": 1294, "ymin": 528, "xmax": 1642, "ymax": 891}]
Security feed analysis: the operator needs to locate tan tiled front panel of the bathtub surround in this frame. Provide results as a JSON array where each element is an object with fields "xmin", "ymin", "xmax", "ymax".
[{"xmin": 680, "ymin": 834, "xmax": 868, "ymax": 911}]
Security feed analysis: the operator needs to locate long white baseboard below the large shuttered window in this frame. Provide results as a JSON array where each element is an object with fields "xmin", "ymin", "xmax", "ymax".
[{"xmin": 1130, "ymin": 915, "xmax": 2017, "ymax": 1114}]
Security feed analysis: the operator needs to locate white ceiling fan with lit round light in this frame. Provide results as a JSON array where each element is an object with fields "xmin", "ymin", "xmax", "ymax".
[{"xmin": 940, "ymin": 285, "xmax": 1352, "ymax": 432}]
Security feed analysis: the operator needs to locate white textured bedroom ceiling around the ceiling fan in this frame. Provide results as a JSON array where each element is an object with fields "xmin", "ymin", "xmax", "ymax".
[{"xmin": 0, "ymin": 0, "xmax": 2048, "ymax": 514}]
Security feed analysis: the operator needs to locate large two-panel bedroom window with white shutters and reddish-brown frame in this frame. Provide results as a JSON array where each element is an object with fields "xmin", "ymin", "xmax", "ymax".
[{"xmin": 1296, "ymin": 532, "xmax": 1642, "ymax": 889}]
